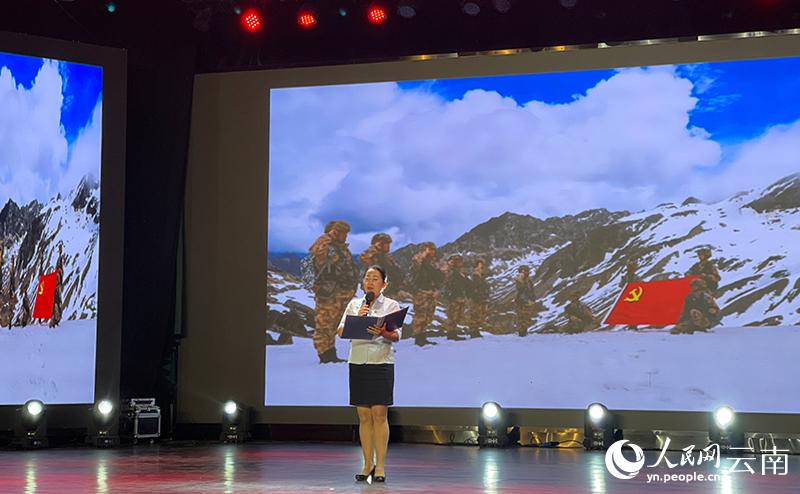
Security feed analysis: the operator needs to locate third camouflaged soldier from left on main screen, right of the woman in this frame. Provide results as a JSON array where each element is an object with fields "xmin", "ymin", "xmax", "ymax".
[{"xmin": 409, "ymin": 242, "xmax": 444, "ymax": 346}]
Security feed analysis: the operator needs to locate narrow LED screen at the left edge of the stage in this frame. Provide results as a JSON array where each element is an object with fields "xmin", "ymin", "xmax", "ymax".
[{"xmin": 0, "ymin": 52, "xmax": 103, "ymax": 404}]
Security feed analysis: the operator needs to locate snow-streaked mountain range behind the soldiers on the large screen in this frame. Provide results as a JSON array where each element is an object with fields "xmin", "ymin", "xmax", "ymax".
[{"xmin": 267, "ymin": 174, "xmax": 800, "ymax": 342}]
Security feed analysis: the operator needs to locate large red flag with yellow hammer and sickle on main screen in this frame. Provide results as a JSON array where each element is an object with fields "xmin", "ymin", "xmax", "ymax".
[{"xmin": 605, "ymin": 276, "xmax": 697, "ymax": 326}]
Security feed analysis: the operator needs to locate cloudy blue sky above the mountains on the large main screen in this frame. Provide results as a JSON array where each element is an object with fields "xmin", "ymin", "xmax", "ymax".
[{"xmin": 268, "ymin": 58, "xmax": 800, "ymax": 251}]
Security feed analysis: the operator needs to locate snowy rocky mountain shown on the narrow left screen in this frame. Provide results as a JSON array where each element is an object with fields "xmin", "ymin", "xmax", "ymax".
[{"xmin": 0, "ymin": 177, "xmax": 100, "ymax": 321}]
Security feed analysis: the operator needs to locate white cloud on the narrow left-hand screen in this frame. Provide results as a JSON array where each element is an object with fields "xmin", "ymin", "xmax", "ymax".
[{"xmin": 0, "ymin": 60, "xmax": 102, "ymax": 207}]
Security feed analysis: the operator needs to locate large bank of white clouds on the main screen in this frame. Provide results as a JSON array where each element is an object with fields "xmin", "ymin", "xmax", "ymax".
[{"xmin": 269, "ymin": 67, "xmax": 796, "ymax": 251}]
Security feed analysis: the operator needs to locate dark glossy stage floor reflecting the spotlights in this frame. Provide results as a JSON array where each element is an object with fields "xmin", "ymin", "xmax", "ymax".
[{"xmin": 0, "ymin": 443, "xmax": 800, "ymax": 494}]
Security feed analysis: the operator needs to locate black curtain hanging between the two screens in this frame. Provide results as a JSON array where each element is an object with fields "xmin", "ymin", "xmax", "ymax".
[{"xmin": 121, "ymin": 39, "xmax": 194, "ymax": 432}]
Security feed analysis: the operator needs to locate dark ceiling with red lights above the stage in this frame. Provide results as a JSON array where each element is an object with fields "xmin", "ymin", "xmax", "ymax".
[{"xmin": 0, "ymin": 0, "xmax": 800, "ymax": 72}]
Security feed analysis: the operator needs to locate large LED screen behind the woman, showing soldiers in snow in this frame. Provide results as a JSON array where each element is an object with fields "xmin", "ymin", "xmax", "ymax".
[{"xmin": 265, "ymin": 58, "xmax": 800, "ymax": 412}]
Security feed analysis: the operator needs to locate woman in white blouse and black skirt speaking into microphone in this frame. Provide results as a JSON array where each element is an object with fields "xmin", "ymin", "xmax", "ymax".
[{"xmin": 339, "ymin": 266, "xmax": 400, "ymax": 482}]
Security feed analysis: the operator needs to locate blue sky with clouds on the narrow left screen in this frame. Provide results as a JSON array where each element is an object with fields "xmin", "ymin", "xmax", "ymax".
[{"xmin": 0, "ymin": 52, "xmax": 103, "ymax": 203}]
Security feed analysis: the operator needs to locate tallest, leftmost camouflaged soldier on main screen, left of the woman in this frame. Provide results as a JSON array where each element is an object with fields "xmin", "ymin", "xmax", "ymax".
[{"xmin": 309, "ymin": 221, "xmax": 359, "ymax": 364}]
